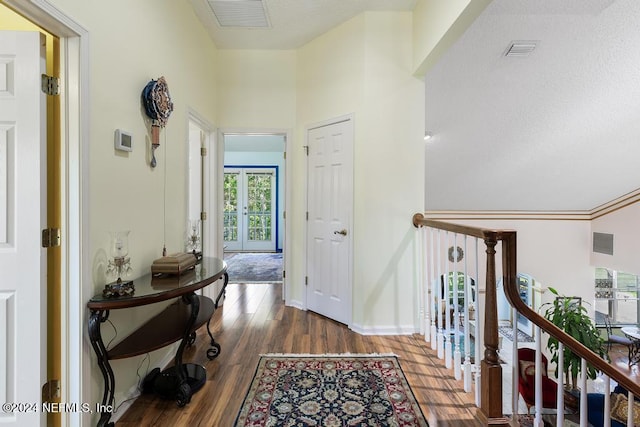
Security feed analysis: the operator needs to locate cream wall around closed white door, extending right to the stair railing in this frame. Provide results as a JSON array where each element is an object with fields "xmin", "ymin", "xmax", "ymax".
[{"xmin": 293, "ymin": 12, "xmax": 424, "ymax": 333}]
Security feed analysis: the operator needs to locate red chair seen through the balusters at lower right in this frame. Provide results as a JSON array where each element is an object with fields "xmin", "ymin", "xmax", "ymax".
[{"xmin": 518, "ymin": 348, "xmax": 558, "ymax": 413}]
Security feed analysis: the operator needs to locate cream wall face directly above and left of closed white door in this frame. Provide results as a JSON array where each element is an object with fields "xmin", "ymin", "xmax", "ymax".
[{"xmin": 294, "ymin": 15, "xmax": 364, "ymax": 306}]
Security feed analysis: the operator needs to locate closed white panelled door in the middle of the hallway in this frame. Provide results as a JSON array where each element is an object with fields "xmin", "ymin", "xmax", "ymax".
[{"xmin": 307, "ymin": 120, "xmax": 353, "ymax": 324}]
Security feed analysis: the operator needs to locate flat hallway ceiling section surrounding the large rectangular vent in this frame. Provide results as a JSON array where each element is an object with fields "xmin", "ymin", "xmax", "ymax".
[{"xmin": 190, "ymin": 0, "xmax": 417, "ymax": 49}]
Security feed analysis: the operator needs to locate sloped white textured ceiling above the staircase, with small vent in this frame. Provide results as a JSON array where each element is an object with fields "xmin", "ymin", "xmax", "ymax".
[{"xmin": 425, "ymin": 0, "xmax": 640, "ymax": 211}]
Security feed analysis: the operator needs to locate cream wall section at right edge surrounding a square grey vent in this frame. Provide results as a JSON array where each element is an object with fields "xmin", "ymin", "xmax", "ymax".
[{"xmin": 588, "ymin": 202, "xmax": 640, "ymax": 275}]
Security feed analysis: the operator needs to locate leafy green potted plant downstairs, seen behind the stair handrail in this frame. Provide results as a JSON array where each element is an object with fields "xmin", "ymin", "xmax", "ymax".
[{"xmin": 544, "ymin": 288, "xmax": 609, "ymax": 390}]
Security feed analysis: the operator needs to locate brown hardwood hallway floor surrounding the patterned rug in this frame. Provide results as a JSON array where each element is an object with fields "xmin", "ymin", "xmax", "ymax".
[{"xmin": 116, "ymin": 284, "xmax": 482, "ymax": 427}]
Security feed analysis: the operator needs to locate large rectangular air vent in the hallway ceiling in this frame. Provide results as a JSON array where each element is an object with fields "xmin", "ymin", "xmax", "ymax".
[{"xmin": 208, "ymin": 0, "xmax": 270, "ymax": 28}]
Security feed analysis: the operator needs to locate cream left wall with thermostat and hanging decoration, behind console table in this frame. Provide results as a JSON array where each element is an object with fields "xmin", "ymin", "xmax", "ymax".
[{"xmin": 46, "ymin": 0, "xmax": 217, "ymax": 423}]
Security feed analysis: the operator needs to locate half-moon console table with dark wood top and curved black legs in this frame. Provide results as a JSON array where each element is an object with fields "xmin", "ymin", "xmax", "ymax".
[{"xmin": 87, "ymin": 257, "xmax": 229, "ymax": 427}]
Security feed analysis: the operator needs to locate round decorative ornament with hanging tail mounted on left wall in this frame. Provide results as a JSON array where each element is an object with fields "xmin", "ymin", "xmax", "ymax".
[{"xmin": 142, "ymin": 76, "xmax": 173, "ymax": 168}]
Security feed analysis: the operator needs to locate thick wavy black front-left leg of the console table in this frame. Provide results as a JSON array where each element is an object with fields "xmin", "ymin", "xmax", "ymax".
[{"xmin": 89, "ymin": 310, "xmax": 115, "ymax": 427}]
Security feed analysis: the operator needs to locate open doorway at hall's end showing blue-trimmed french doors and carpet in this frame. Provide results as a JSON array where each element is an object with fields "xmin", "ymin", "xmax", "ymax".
[{"xmin": 222, "ymin": 132, "xmax": 286, "ymax": 283}]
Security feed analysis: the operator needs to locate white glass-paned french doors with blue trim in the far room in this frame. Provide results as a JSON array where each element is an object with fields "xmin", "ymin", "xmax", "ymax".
[{"xmin": 224, "ymin": 167, "xmax": 276, "ymax": 251}]
